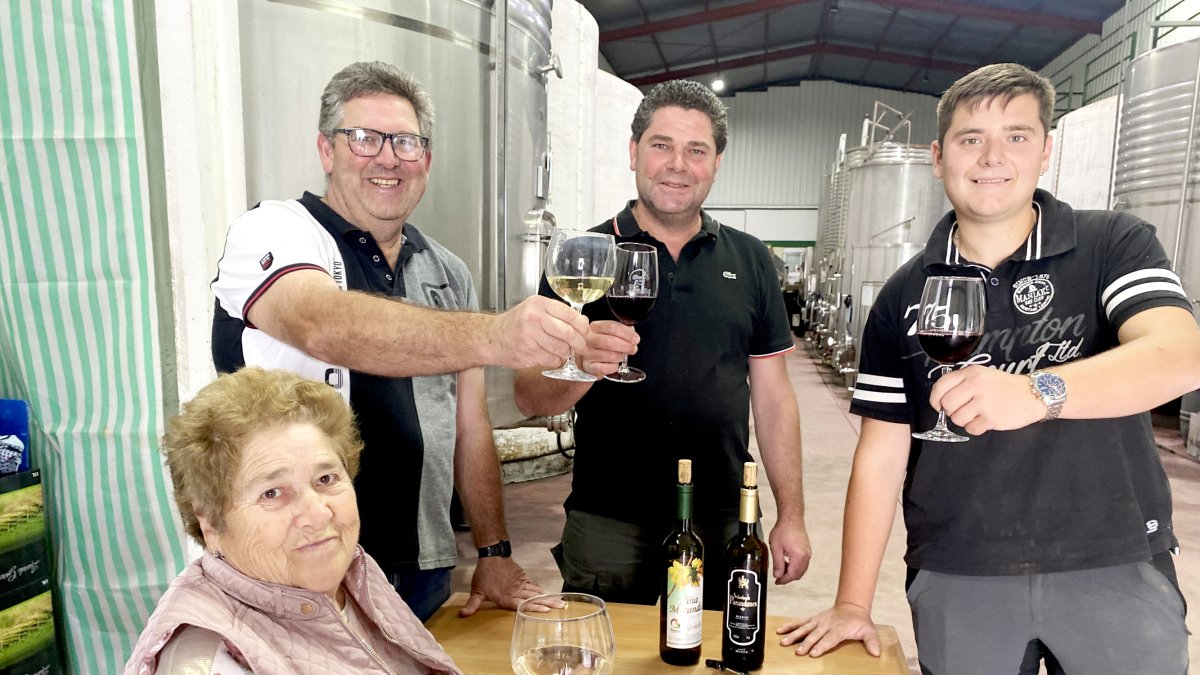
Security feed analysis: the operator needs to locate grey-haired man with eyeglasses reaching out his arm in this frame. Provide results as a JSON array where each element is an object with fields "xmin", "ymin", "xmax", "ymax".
[{"xmin": 212, "ymin": 61, "xmax": 576, "ymax": 621}]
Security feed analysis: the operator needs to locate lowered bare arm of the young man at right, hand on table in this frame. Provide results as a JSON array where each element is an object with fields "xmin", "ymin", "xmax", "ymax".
[{"xmin": 779, "ymin": 417, "xmax": 911, "ymax": 656}]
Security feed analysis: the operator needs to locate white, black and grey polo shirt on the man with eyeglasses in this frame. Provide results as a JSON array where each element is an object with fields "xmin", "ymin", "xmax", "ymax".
[{"xmin": 212, "ymin": 192, "xmax": 479, "ymax": 573}]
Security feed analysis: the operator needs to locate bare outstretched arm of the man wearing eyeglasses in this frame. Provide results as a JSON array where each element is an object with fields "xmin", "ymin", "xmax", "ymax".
[{"xmin": 246, "ymin": 269, "xmax": 587, "ymax": 377}]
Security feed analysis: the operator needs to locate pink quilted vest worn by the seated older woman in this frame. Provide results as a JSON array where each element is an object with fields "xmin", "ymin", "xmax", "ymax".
[{"xmin": 125, "ymin": 546, "xmax": 461, "ymax": 675}]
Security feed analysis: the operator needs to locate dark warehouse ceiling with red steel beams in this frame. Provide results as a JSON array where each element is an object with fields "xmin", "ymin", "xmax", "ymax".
[{"xmin": 580, "ymin": 0, "xmax": 1124, "ymax": 95}]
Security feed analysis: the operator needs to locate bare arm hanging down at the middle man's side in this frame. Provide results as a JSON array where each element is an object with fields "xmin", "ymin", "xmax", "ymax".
[{"xmin": 750, "ymin": 354, "xmax": 812, "ymax": 584}]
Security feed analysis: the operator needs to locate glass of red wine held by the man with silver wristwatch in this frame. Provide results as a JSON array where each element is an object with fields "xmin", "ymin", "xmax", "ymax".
[{"xmin": 912, "ymin": 276, "xmax": 988, "ymax": 443}]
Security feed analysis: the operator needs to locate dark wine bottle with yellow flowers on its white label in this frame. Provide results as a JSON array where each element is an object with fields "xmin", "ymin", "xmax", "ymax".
[{"xmin": 659, "ymin": 459, "xmax": 704, "ymax": 665}]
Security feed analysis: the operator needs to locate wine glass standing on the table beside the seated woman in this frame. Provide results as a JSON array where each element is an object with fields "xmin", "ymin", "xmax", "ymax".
[{"xmin": 509, "ymin": 593, "xmax": 617, "ymax": 675}]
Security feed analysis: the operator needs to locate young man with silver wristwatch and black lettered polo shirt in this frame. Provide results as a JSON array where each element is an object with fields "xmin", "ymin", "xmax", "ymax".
[{"xmin": 780, "ymin": 64, "xmax": 1200, "ymax": 675}]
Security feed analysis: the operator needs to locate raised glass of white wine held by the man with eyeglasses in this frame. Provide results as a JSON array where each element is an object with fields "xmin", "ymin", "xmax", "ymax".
[{"xmin": 541, "ymin": 227, "xmax": 617, "ymax": 382}]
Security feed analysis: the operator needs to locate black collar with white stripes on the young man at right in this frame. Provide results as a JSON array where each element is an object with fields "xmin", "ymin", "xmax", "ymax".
[{"xmin": 922, "ymin": 190, "xmax": 1075, "ymax": 268}]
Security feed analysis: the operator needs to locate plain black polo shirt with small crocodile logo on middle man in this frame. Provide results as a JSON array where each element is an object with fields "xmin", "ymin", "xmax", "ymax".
[{"xmin": 540, "ymin": 202, "xmax": 794, "ymax": 527}]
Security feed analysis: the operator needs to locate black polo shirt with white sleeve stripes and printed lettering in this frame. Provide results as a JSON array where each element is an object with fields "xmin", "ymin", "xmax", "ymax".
[{"xmin": 851, "ymin": 190, "xmax": 1190, "ymax": 574}]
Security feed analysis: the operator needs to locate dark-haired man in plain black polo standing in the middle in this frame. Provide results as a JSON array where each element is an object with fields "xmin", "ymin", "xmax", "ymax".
[{"xmin": 516, "ymin": 80, "xmax": 810, "ymax": 609}]
